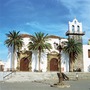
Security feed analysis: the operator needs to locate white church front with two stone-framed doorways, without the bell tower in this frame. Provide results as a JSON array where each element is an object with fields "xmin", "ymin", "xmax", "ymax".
[{"xmin": 4, "ymin": 34, "xmax": 69, "ymax": 72}]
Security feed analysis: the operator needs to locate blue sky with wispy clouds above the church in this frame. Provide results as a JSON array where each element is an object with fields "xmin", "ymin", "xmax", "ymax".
[{"xmin": 0, "ymin": 0, "xmax": 90, "ymax": 61}]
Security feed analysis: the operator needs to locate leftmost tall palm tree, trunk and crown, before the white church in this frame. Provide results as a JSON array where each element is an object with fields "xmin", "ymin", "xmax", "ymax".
[{"xmin": 5, "ymin": 30, "xmax": 23, "ymax": 70}]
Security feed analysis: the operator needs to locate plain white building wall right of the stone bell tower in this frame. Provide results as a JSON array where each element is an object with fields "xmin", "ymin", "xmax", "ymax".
[{"xmin": 83, "ymin": 45, "xmax": 90, "ymax": 72}]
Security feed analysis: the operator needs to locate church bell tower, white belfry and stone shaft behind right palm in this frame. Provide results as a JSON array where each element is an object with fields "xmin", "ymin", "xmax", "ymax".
[{"xmin": 66, "ymin": 18, "xmax": 85, "ymax": 71}]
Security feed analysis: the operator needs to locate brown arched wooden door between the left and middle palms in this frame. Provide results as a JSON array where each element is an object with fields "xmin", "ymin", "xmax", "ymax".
[{"xmin": 20, "ymin": 58, "xmax": 29, "ymax": 71}]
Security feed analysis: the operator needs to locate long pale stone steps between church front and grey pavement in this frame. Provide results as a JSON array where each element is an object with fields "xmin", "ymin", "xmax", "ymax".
[{"xmin": 6, "ymin": 72, "xmax": 90, "ymax": 81}]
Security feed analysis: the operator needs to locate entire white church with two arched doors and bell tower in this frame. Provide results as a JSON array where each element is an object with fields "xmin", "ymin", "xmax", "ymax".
[{"xmin": 4, "ymin": 19, "xmax": 90, "ymax": 72}]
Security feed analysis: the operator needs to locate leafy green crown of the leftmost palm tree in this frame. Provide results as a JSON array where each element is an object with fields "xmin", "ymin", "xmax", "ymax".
[{"xmin": 4, "ymin": 30, "xmax": 23, "ymax": 51}]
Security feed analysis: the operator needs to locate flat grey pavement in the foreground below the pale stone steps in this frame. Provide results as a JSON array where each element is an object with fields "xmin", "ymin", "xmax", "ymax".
[{"xmin": 0, "ymin": 80, "xmax": 90, "ymax": 90}]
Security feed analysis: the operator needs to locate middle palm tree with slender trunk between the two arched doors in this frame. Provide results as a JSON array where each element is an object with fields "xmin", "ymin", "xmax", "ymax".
[{"xmin": 28, "ymin": 32, "xmax": 52, "ymax": 71}]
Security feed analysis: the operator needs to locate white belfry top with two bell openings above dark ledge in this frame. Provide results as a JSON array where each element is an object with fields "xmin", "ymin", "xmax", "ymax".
[{"xmin": 66, "ymin": 18, "xmax": 85, "ymax": 43}]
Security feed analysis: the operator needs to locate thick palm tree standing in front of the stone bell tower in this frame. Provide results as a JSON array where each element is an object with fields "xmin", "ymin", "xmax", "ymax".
[{"xmin": 64, "ymin": 38, "xmax": 82, "ymax": 72}]
